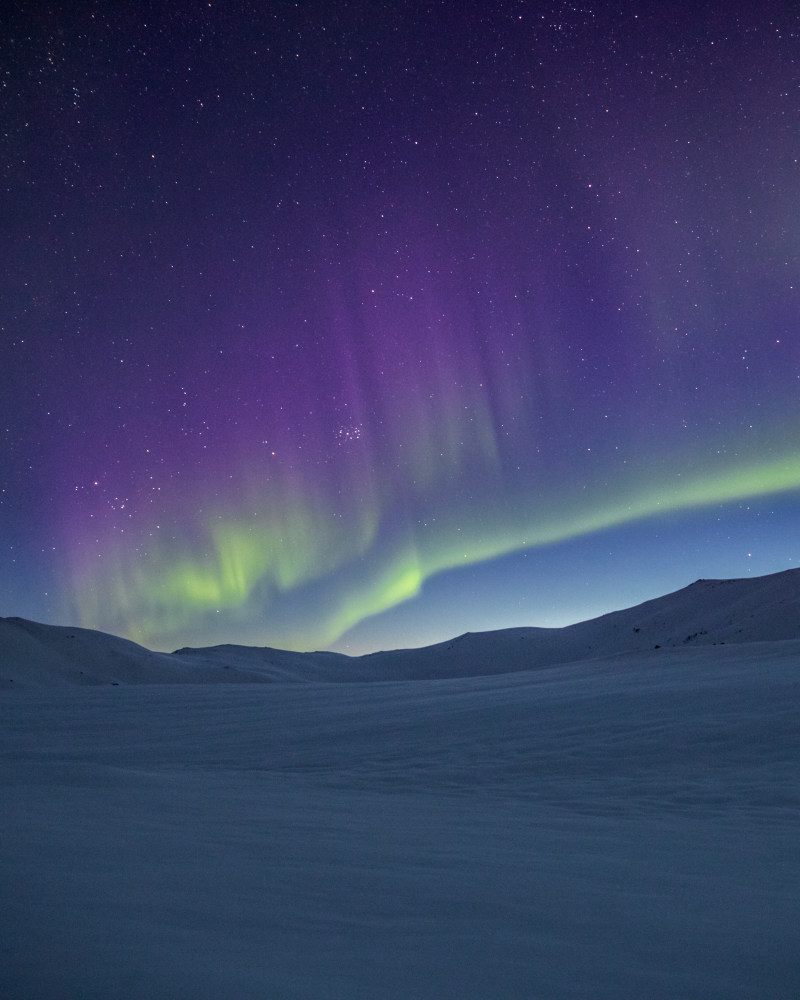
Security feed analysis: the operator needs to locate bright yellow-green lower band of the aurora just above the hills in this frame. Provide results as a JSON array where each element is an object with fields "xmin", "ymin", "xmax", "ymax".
[{"xmin": 73, "ymin": 452, "xmax": 800, "ymax": 649}]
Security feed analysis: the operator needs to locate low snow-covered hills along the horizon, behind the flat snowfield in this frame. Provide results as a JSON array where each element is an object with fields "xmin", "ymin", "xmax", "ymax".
[{"xmin": 0, "ymin": 569, "xmax": 800, "ymax": 686}]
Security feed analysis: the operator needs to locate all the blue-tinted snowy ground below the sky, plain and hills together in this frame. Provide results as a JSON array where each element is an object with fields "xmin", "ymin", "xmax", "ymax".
[{"xmin": 0, "ymin": 571, "xmax": 800, "ymax": 1000}]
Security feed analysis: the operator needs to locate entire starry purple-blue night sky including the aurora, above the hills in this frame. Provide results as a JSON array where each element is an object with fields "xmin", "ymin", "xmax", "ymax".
[{"xmin": 0, "ymin": 0, "xmax": 800, "ymax": 653}]
